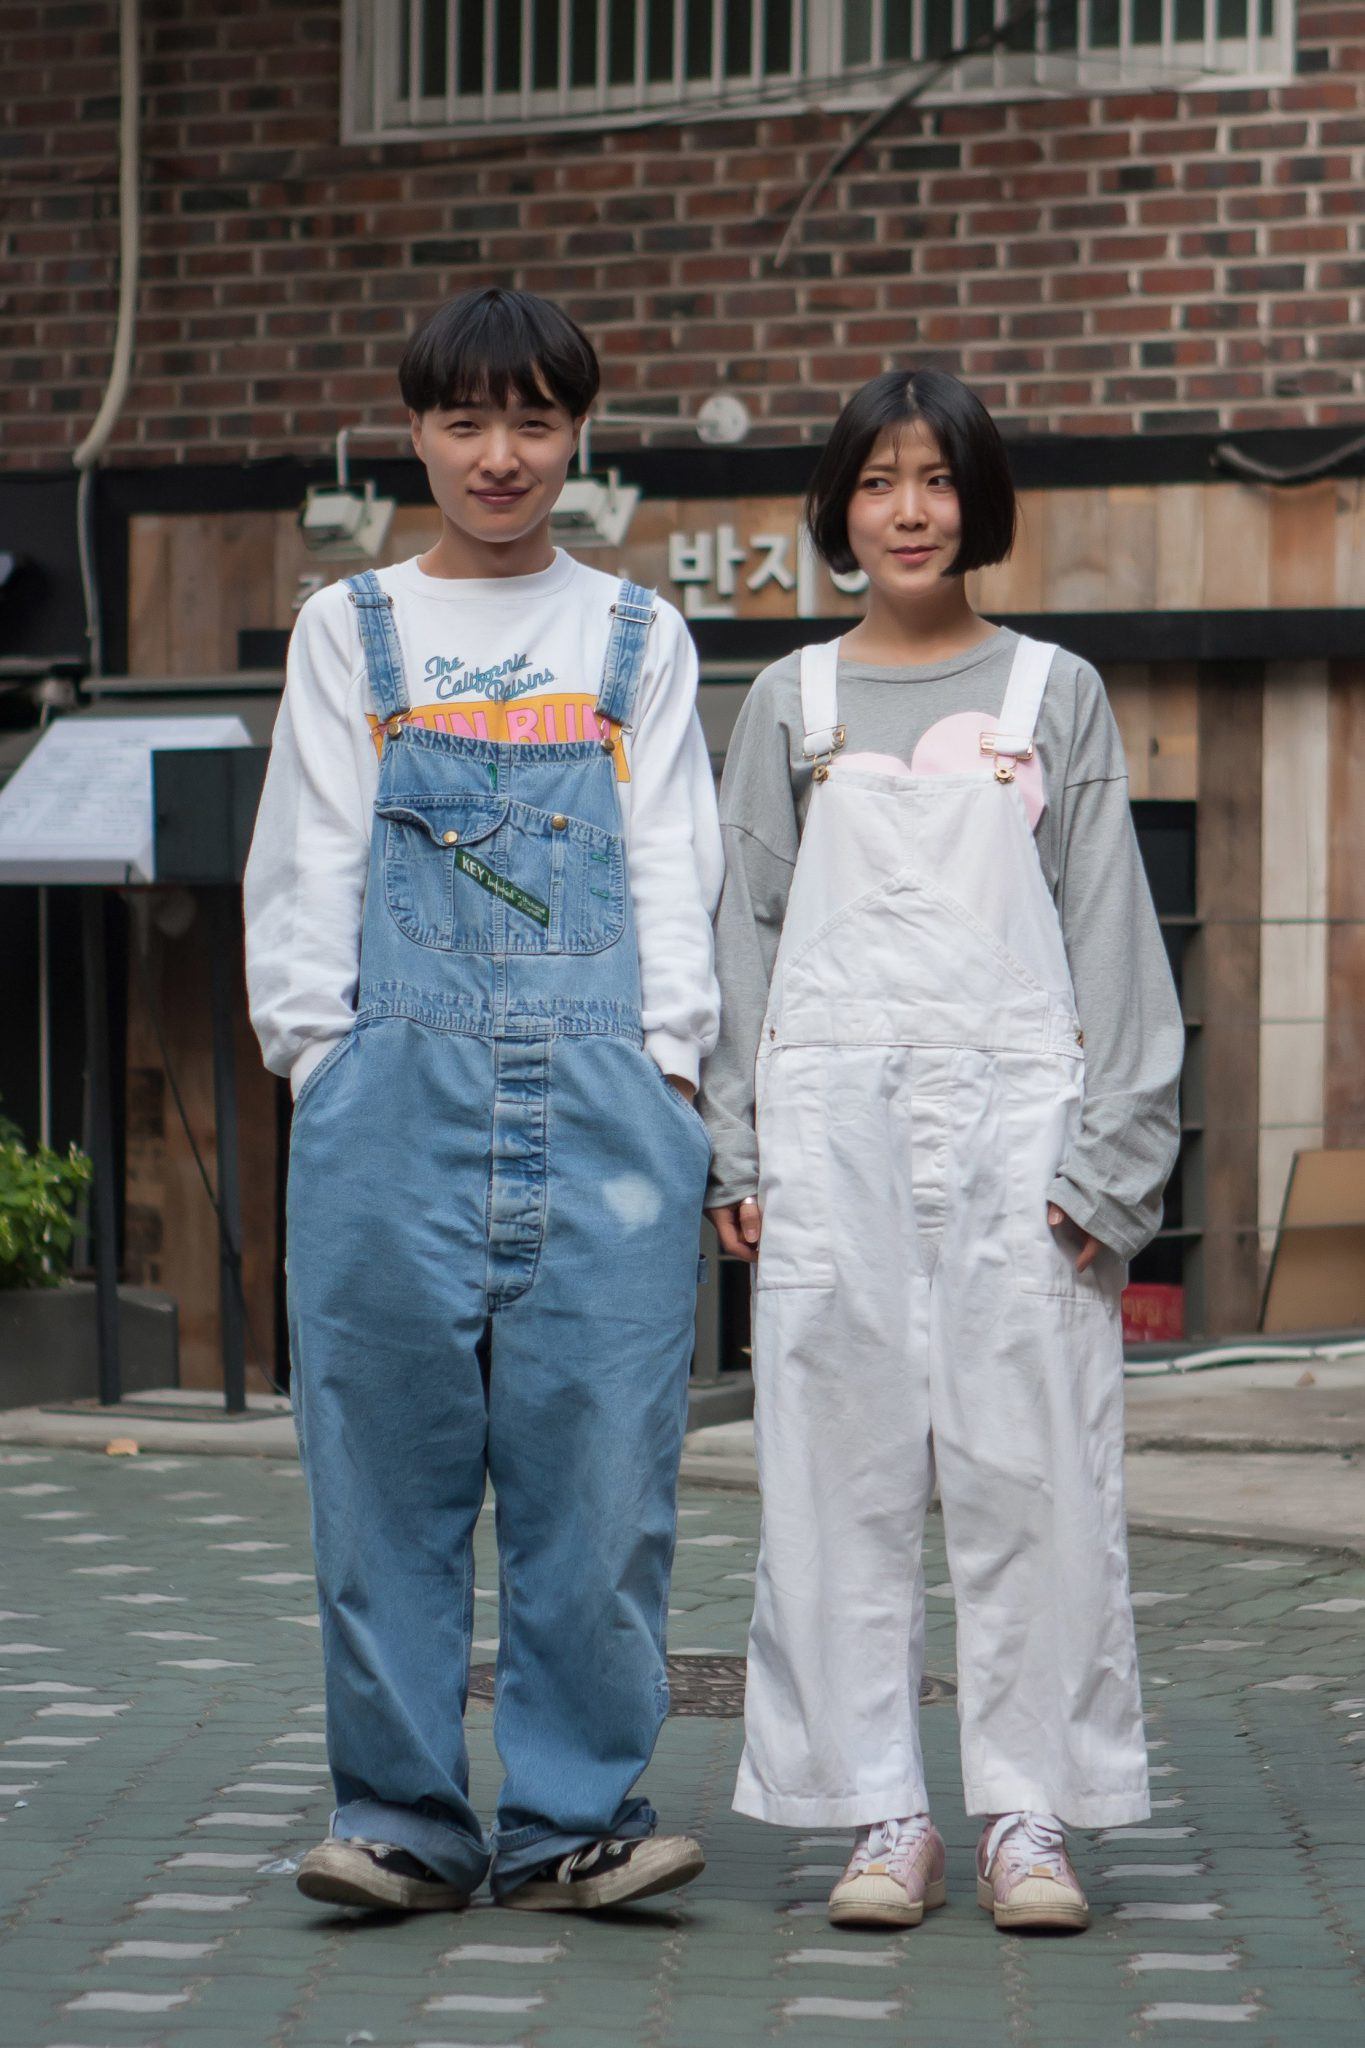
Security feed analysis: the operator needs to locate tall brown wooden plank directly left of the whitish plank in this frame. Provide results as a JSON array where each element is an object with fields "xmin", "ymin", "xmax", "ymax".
[{"xmin": 1187, "ymin": 664, "xmax": 1263, "ymax": 1335}]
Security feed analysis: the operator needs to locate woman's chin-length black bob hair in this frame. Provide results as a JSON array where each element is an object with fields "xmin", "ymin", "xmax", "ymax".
[{"xmin": 806, "ymin": 371, "xmax": 1015, "ymax": 575}]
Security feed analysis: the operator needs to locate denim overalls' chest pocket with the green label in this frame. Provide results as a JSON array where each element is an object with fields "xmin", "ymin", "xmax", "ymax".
[{"xmin": 375, "ymin": 793, "xmax": 626, "ymax": 952}]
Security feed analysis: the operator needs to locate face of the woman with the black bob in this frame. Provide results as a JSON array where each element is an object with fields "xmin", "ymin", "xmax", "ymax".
[{"xmin": 847, "ymin": 420, "xmax": 962, "ymax": 600}]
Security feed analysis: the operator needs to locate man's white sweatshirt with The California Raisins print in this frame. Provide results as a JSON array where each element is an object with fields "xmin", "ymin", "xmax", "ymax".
[{"xmin": 244, "ymin": 549, "xmax": 724, "ymax": 1094}]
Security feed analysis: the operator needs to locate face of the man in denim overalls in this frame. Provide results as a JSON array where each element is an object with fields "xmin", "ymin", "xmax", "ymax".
[{"xmin": 409, "ymin": 391, "xmax": 581, "ymax": 543}]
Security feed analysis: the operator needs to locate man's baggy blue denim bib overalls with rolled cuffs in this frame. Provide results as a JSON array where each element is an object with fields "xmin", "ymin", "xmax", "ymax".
[{"xmin": 289, "ymin": 571, "xmax": 710, "ymax": 1892}]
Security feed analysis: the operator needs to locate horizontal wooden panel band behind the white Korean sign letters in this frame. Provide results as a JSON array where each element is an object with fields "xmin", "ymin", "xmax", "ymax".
[{"xmin": 129, "ymin": 479, "xmax": 1365, "ymax": 676}]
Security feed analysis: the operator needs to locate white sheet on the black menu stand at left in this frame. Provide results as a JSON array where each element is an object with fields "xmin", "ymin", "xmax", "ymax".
[{"xmin": 0, "ymin": 717, "xmax": 252, "ymax": 883}]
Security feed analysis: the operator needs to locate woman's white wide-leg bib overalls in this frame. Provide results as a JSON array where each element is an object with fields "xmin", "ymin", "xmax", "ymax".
[{"xmin": 735, "ymin": 641, "xmax": 1148, "ymax": 1827}]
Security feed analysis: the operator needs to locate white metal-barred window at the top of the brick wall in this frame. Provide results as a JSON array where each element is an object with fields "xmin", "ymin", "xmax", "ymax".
[{"xmin": 342, "ymin": 0, "xmax": 1293, "ymax": 141}]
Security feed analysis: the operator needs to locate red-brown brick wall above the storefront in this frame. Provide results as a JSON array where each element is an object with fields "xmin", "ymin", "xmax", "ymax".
[{"xmin": 0, "ymin": 0, "xmax": 1365, "ymax": 467}]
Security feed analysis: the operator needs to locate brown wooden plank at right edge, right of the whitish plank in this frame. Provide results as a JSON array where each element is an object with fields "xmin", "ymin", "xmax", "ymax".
[{"xmin": 1324, "ymin": 662, "xmax": 1365, "ymax": 1145}]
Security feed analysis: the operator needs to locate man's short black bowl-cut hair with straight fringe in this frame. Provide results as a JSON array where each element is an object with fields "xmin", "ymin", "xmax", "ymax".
[{"xmin": 399, "ymin": 285, "xmax": 602, "ymax": 420}]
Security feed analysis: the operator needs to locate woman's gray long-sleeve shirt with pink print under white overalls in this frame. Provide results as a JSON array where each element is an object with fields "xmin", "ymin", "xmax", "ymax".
[{"xmin": 698, "ymin": 629, "xmax": 1185, "ymax": 1260}]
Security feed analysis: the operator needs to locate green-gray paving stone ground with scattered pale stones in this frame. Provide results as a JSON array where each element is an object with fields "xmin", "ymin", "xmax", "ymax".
[{"xmin": 0, "ymin": 1450, "xmax": 1365, "ymax": 2048}]
